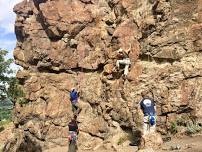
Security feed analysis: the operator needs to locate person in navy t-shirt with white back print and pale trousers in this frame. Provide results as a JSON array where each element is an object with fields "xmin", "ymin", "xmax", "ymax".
[{"xmin": 140, "ymin": 91, "xmax": 156, "ymax": 136}]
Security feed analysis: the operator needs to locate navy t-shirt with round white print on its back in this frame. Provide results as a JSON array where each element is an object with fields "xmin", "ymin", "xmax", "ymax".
[{"xmin": 140, "ymin": 98, "xmax": 156, "ymax": 116}]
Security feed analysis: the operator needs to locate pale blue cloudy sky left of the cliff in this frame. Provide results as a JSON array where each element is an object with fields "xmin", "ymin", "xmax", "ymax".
[{"xmin": 0, "ymin": 0, "xmax": 22, "ymax": 71}]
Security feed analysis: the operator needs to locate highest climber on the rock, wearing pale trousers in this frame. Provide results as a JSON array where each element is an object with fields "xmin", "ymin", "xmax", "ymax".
[{"xmin": 116, "ymin": 44, "xmax": 131, "ymax": 77}]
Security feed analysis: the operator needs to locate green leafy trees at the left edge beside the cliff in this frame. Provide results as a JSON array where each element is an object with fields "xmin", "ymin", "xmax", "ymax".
[{"xmin": 0, "ymin": 49, "xmax": 28, "ymax": 125}]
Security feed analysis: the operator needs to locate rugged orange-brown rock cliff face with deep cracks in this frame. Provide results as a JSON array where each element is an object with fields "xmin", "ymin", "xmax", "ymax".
[{"xmin": 7, "ymin": 0, "xmax": 202, "ymax": 151}]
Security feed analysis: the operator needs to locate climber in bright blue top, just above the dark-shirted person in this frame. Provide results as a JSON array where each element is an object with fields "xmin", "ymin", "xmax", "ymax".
[{"xmin": 70, "ymin": 88, "xmax": 81, "ymax": 115}]
